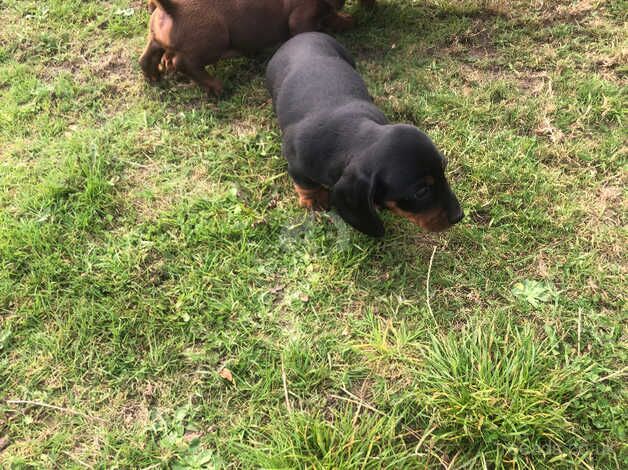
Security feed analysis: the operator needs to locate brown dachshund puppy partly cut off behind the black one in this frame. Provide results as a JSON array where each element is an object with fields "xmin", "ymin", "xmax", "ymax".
[{"xmin": 140, "ymin": 0, "xmax": 375, "ymax": 94}]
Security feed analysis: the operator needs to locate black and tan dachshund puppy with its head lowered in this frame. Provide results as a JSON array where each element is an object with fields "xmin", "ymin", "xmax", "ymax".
[{"xmin": 266, "ymin": 33, "xmax": 463, "ymax": 237}]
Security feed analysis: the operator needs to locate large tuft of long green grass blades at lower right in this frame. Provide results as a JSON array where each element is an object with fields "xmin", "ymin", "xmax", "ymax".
[{"xmin": 403, "ymin": 327, "xmax": 590, "ymax": 468}]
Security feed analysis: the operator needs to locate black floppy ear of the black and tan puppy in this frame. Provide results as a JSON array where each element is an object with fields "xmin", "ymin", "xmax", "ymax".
[{"xmin": 331, "ymin": 167, "xmax": 384, "ymax": 237}]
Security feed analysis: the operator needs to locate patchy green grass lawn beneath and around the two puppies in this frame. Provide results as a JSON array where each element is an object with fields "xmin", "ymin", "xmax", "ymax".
[{"xmin": 0, "ymin": 0, "xmax": 628, "ymax": 469}]
